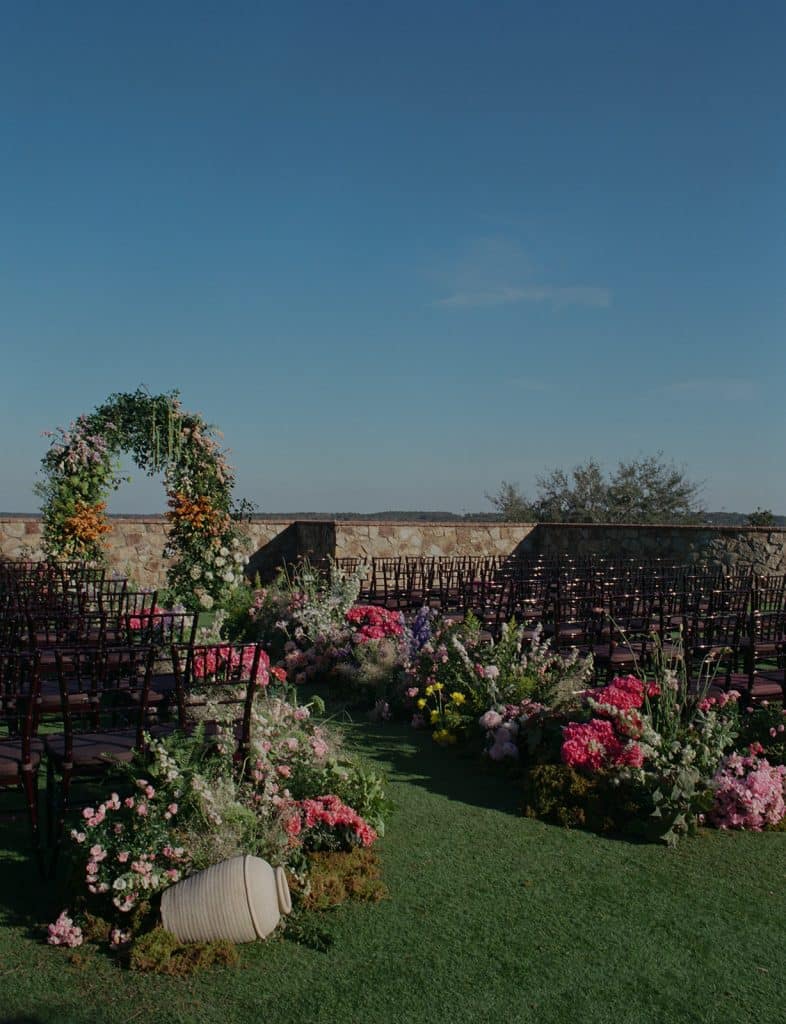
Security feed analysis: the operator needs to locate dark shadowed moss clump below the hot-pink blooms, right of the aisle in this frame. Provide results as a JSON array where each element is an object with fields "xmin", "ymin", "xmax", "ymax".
[{"xmin": 522, "ymin": 764, "xmax": 651, "ymax": 833}]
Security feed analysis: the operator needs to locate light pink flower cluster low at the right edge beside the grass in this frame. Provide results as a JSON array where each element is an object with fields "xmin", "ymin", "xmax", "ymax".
[{"xmin": 710, "ymin": 744, "xmax": 786, "ymax": 831}]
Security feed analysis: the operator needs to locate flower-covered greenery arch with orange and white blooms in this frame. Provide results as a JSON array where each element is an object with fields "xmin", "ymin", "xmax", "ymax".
[{"xmin": 36, "ymin": 389, "xmax": 245, "ymax": 608}]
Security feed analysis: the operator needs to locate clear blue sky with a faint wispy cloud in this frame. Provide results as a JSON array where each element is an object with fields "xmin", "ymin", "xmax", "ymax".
[{"xmin": 0, "ymin": 0, "xmax": 786, "ymax": 512}]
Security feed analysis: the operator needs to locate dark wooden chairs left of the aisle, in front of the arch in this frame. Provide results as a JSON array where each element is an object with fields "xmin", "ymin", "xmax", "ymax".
[{"xmin": 0, "ymin": 573, "xmax": 266, "ymax": 869}]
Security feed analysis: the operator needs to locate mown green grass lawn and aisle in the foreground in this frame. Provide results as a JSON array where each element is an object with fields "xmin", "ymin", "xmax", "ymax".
[{"xmin": 0, "ymin": 725, "xmax": 786, "ymax": 1024}]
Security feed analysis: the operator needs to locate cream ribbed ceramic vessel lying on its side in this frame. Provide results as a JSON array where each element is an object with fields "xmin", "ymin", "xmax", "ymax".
[{"xmin": 161, "ymin": 854, "xmax": 292, "ymax": 942}]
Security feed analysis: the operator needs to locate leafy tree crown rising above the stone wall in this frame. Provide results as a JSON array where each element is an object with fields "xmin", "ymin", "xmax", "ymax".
[{"xmin": 486, "ymin": 452, "xmax": 701, "ymax": 523}]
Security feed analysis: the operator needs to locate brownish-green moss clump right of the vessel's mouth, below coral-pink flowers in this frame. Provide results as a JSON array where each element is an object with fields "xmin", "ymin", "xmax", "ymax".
[{"xmin": 290, "ymin": 847, "xmax": 388, "ymax": 910}]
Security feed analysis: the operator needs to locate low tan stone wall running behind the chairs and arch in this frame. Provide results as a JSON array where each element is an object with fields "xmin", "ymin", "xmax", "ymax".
[{"xmin": 0, "ymin": 516, "xmax": 786, "ymax": 587}]
